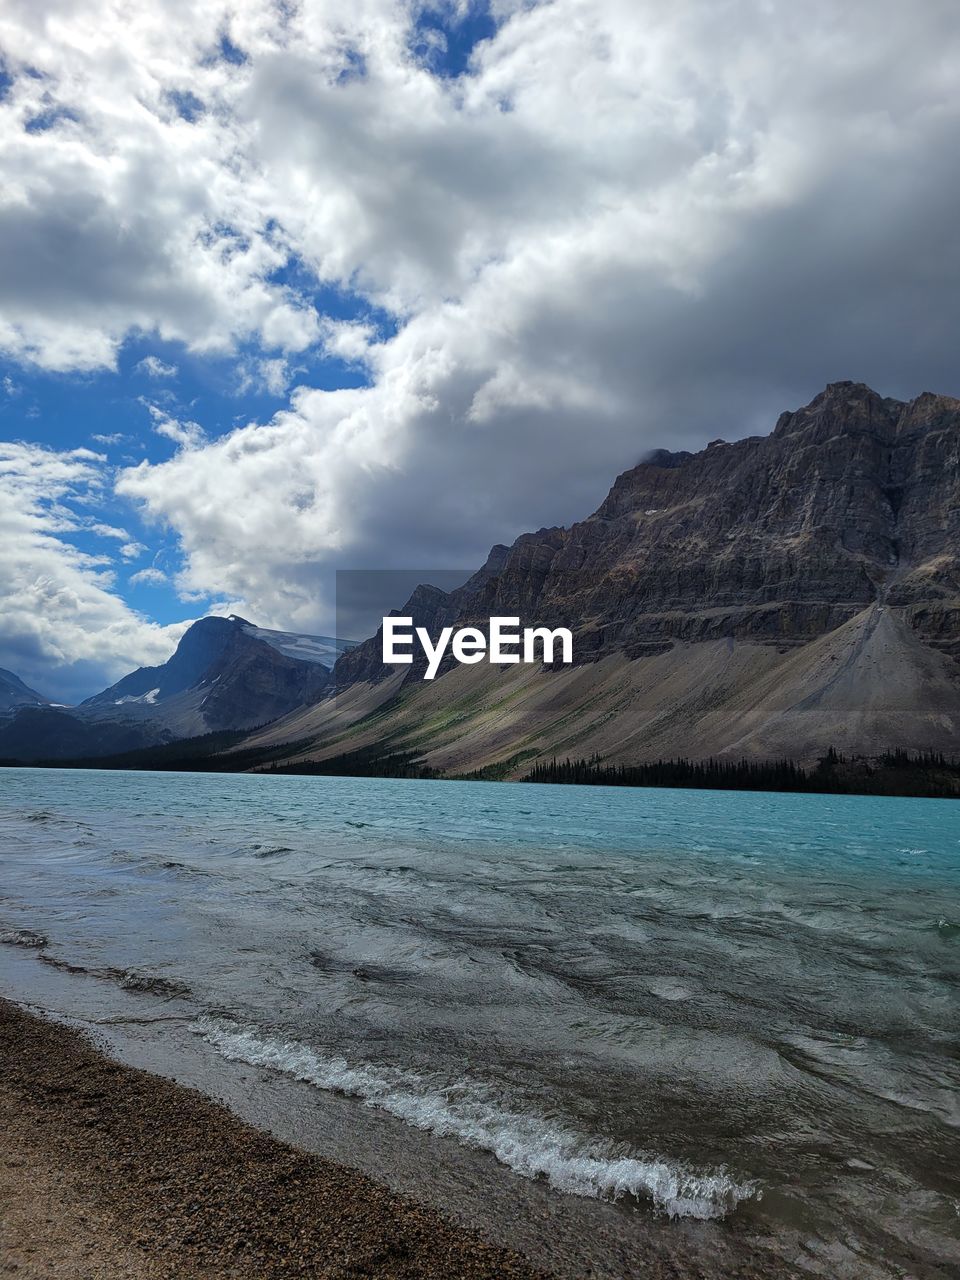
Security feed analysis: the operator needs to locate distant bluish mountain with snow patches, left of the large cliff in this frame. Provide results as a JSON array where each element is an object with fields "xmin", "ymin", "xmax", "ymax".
[{"xmin": 0, "ymin": 616, "xmax": 347, "ymax": 759}]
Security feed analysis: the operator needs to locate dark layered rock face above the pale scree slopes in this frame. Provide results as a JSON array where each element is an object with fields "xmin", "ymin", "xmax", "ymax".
[{"xmin": 335, "ymin": 383, "xmax": 960, "ymax": 686}]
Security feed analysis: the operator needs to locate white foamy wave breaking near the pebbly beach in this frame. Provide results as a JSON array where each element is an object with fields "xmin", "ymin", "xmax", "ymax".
[{"xmin": 191, "ymin": 1018, "xmax": 756, "ymax": 1219}]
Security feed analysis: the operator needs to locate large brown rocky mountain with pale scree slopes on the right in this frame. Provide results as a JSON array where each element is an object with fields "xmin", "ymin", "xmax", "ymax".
[{"xmin": 236, "ymin": 383, "xmax": 960, "ymax": 776}]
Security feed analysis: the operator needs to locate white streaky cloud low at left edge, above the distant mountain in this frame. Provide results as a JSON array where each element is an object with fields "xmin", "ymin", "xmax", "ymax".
[{"xmin": 0, "ymin": 443, "xmax": 187, "ymax": 703}]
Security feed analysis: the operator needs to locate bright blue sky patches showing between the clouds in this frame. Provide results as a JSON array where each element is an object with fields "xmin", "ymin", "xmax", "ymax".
[{"xmin": 0, "ymin": 0, "xmax": 497, "ymax": 670}]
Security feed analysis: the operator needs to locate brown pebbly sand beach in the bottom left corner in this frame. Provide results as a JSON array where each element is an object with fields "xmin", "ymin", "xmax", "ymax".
[{"xmin": 0, "ymin": 1000, "xmax": 555, "ymax": 1280}]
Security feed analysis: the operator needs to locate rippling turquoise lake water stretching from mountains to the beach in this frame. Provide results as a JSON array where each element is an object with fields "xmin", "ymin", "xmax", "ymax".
[{"xmin": 0, "ymin": 769, "xmax": 960, "ymax": 1276}]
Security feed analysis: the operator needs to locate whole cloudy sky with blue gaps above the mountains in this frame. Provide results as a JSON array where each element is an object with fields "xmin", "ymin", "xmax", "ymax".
[{"xmin": 0, "ymin": 0, "xmax": 960, "ymax": 701}]
